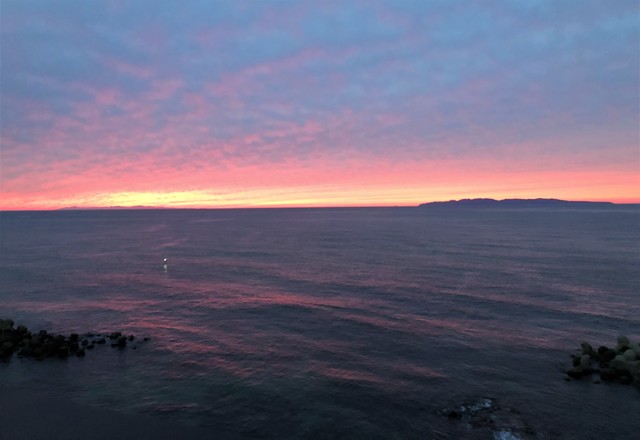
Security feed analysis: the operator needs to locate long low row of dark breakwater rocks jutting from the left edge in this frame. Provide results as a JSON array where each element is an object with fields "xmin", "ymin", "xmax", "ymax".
[{"xmin": 0, "ymin": 319, "xmax": 149, "ymax": 360}]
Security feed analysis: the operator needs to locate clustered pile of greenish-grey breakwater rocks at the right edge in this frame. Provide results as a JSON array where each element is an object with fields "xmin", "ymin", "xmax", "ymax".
[{"xmin": 567, "ymin": 336, "xmax": 640, "ymax": 388}]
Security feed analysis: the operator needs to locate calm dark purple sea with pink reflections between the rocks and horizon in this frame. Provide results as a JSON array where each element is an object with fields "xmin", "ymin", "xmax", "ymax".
[{"xmin": 0, "ymin": 207, "xmax": 640, "ymax": 439}]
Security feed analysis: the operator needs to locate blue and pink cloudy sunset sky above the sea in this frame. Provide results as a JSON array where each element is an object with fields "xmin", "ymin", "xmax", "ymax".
[{"xmin": 0, "ymin": 0, "xmax": 640, "ymax": 210}]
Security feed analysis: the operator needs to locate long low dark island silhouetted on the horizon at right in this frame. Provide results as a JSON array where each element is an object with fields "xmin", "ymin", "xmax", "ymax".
[{"xmin": 420, "ymin": 199, "xmax": 615, "ymax": 208}]
